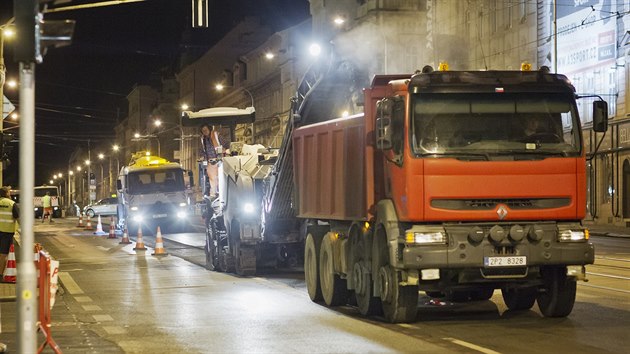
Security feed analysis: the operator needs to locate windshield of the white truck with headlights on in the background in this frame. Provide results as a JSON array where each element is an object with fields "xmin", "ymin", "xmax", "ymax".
[{"xmin": 128, "ymin": 169, "xmax": 186, "ymax": 194}]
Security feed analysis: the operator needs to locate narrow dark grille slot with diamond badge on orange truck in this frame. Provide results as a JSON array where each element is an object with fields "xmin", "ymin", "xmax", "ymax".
[{"xmin": 431, "ymin": 198, "xmax": 571, "ymax": 210}]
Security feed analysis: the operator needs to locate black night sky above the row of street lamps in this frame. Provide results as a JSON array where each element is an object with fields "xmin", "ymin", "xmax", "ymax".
[{"xmin": 0, "ymin": 0, "xmax": 309, "ymax": 186}]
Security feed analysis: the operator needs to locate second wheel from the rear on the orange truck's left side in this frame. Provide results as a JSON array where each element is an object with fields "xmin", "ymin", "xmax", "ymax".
[{"xmin": 319, "ymin": 232, "xmax": 348, "ymax": 306}]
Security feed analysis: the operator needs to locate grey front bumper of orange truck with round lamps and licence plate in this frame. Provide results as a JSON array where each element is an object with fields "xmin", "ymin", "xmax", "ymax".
[{"xmin": 398, "ymin": 222, "xmax": 595, "ymax": 278}]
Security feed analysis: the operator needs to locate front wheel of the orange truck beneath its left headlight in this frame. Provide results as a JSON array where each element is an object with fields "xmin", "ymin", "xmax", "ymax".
[{"xmin": 379, "ymin": 264, "xmax": 418, "ymax": 323}]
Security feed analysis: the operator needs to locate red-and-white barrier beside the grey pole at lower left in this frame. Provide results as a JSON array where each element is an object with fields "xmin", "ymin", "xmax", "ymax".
[{"xmin": 37, "ymin": 251, "xmax": 61, "ymax": 354}]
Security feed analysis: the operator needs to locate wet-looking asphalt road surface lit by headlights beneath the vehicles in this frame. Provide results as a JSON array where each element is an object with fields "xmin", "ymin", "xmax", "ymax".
[{"xmin": 0, "ymin": 219, "xmax": 630, "ymax": 353}]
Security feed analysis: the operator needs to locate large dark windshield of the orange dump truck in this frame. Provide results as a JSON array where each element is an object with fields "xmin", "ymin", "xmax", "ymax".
[{"xmin": 411, "ymin": 93, "xmax": 582, "ymax": 158}]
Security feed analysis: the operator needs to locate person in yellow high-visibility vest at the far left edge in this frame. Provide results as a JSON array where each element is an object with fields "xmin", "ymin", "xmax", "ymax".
[{"xmin": 0, "ymin": 187, "xmax": 14, "ymax": 353}]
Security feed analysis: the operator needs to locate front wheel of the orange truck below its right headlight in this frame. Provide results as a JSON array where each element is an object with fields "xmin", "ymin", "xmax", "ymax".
[{"xmin": 537, "ymin": 267, "xmax": 576, "ymax": 317}]
